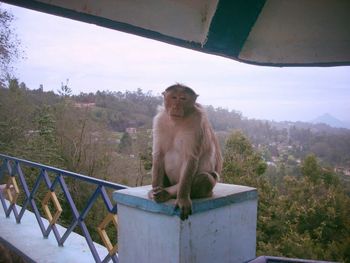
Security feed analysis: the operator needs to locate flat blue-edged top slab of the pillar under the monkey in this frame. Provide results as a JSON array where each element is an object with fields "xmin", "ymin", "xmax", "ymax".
[{"xmin": 113, "ymin": 183, "xmax": 257, "ymax": 219}]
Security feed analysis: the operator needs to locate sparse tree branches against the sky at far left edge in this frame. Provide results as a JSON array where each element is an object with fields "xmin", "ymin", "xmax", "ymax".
[{"xmin": 0, "ymin": 3, "xmax": 21, "ymax": 86}]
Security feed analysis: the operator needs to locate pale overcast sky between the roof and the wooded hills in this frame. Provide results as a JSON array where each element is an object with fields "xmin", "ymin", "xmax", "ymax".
[{"xmin": 2, "ymin": 4, "xmax": 350, "ymax": 122}]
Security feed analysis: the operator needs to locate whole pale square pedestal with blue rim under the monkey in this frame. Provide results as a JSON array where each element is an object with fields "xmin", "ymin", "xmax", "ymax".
[{"xmin": 113, "ymin": 184, "xmax": 257, "ymax": 263}]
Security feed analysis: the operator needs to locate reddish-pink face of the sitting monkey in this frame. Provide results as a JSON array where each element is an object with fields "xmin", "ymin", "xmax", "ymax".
[{"xmin": 163, "ymin": 88, "xmax": 197, "ymax": 119}]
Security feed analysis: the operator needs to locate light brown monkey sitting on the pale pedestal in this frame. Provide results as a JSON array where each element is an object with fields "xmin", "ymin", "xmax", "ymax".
[{"xmin": 148, "ymin": 84, "xmax": 222, "ymax": 220}]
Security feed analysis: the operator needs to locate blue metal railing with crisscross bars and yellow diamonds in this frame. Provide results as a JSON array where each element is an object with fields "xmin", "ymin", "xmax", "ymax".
[{"xmin": 0, "ymin": 154, "xmax": 128, "ymax": 262}]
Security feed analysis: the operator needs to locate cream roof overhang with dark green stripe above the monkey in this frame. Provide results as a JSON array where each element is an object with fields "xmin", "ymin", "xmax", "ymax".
[{"xmin": 3, "ymin": 0, "xmax": 350, "ymax": 66}]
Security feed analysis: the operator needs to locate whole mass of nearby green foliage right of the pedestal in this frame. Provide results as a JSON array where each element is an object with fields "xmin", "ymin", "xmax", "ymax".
[{"xmin": 223, "ymin": 132, "xmax": 350, "ymax": 262}]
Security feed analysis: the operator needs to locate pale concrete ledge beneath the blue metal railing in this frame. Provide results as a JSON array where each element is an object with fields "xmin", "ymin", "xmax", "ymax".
[{"xmin": 0, "ymin": 201, "xmax": 108, "ymax": 263}]
